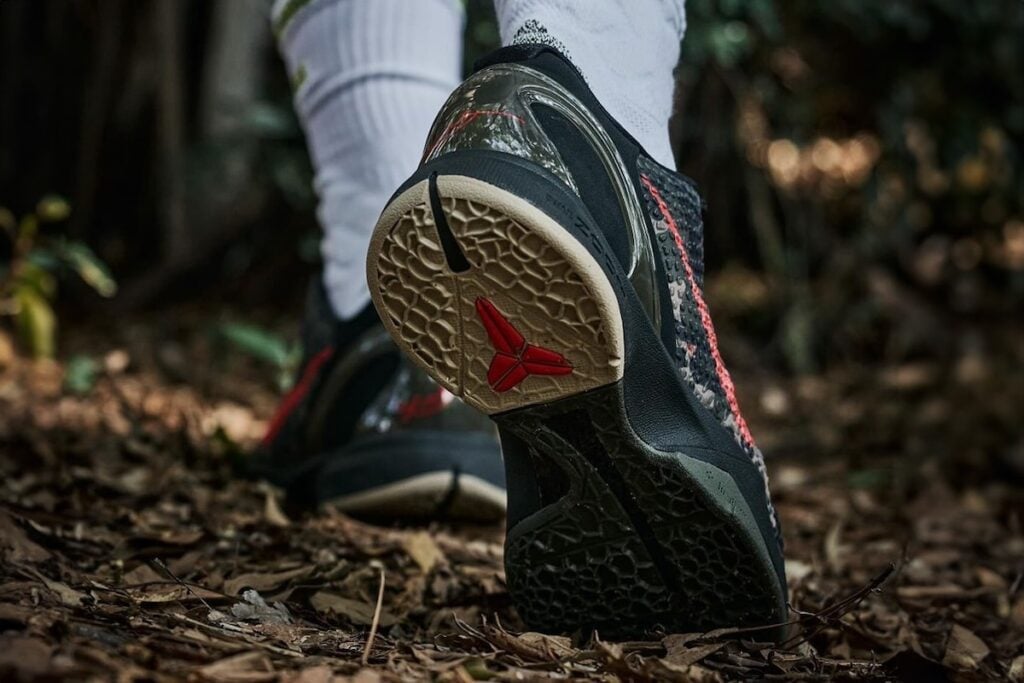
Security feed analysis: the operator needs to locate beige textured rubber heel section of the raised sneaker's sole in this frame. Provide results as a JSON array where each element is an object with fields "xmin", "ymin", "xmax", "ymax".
[{"xmin": 367, "ymin": 175, "xmax": 624, "ymax": 415}]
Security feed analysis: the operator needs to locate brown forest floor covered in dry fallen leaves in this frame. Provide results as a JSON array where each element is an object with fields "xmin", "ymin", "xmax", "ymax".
[{"xmin": 0, "ymin": 313, "xmax": 1024, "ymax": 683}]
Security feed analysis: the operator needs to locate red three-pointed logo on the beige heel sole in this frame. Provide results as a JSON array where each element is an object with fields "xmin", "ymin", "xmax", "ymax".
[{"xmin": 476, "ymin": 297, "xmax": 572, "ymax": 393}]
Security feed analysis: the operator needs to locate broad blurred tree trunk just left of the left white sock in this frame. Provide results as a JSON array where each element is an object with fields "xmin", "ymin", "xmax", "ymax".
[{"xmin": 118, "ymin": 0, "xmax": 270, "ymax": 309}]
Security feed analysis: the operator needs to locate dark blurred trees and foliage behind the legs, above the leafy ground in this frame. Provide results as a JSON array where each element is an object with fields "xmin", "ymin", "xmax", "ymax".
[{"xmin": 0, "ymin": 0, "xmax": 1024, "ymax": 373}]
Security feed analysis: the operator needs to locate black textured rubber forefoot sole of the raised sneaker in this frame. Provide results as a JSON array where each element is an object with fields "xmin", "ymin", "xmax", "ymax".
[{"xmin": 496, "ymin": 383, "xmax": 785, "ymax": 639}]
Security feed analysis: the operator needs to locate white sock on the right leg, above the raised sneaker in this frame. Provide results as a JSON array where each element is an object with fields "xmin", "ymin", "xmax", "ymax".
[{"xmin": 495, "ymin": 0, "xmax": 686, "ymax": 168}]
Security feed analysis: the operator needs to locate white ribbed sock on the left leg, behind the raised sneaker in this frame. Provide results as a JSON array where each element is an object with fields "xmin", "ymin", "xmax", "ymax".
[{"xmin": 273, "ymin": 0, "xmax": 465, "ymax": 319}]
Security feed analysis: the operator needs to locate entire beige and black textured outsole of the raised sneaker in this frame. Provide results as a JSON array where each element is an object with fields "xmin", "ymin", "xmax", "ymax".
[{"xmin": 368, "ymin": 167, "xmax": 785, "ymax": 637}]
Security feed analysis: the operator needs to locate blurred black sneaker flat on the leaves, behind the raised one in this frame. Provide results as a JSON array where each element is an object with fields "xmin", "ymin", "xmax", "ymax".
[{"xmin": 250, "ymin": 286, "xmax": 505, "ymax": 521}]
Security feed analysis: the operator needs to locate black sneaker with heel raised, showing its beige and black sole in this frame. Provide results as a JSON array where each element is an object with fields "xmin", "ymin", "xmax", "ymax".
[{"xmin": 368, "ymin": 45, "xmax": 786, "ymax": 637}]
